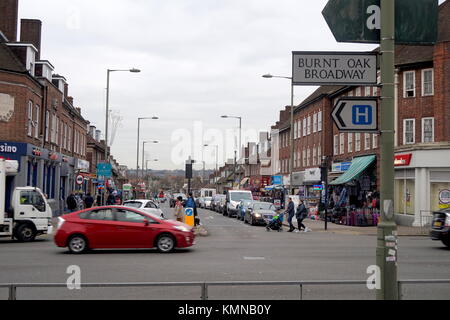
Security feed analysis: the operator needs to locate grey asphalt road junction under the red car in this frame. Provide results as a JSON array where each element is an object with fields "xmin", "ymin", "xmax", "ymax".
[{"xmin": 0, "ymin": 207, "xmax": 450, "ymax": 300}]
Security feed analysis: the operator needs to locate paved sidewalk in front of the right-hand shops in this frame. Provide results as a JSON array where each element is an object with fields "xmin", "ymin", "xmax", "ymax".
[{"xmin": 283, "ymin": 218, "xmax": 429, "ymax": 237}]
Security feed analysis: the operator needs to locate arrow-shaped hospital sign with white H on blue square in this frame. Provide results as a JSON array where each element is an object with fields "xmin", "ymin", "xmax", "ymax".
[{"xmin": 331, "ymin": 98, "xmax": 378, "ymax": 132}]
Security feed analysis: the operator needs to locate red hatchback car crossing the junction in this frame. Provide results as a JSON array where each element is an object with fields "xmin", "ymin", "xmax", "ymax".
[{"xmin": 54, "ymin": 206, "xmax": 195, "ymax": 253}]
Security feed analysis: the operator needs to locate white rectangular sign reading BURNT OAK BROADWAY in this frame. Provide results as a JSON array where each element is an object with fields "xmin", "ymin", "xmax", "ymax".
[{"xmin": 292, "ymin": 51, "xmax": 377, "ymax": 85}]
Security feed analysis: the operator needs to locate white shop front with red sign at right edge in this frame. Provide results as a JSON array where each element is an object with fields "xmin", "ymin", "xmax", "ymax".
[{"xmin": 394, "ymin": 148, "xmax": 450, "ymax": 226}]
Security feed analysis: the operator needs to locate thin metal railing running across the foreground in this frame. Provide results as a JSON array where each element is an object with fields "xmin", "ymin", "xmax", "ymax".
[{"xmin": 0, "ymin": 279, "xmax": 450, "ymax": 300}]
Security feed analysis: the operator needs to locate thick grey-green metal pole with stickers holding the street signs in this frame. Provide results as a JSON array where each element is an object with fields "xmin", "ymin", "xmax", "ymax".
[{"xmin": 376, "ymin": 0, "xmax": 398, "ymax": 300}]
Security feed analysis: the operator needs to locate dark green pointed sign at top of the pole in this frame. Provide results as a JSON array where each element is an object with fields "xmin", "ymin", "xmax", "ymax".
[{"xmin": 322, "ymin": 0, "xmax": 438, "ymax": 44}]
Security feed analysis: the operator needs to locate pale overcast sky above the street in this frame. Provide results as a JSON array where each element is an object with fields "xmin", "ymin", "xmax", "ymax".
[{"xmin": 19, "ymin": 0, "xmax": 400, "ymax": 169}]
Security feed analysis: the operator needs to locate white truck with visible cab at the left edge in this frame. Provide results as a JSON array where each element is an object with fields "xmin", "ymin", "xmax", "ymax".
[{"xmin": 0, "ymin": 159, "xmax": 53, "ymax": 242}]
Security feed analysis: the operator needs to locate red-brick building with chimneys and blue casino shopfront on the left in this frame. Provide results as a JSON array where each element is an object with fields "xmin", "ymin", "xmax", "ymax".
[{"xmin": 0, "ymin": 0, "xmax": 90, "ymax": 215}]
